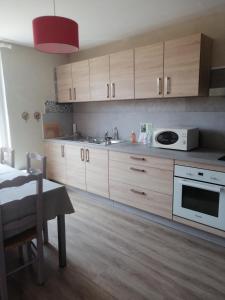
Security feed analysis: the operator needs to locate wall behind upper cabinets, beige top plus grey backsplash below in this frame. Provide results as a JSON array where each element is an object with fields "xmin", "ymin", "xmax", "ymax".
[{"xmin": 70, "ymin": 9, "xmax": 225, "ymax": 150}]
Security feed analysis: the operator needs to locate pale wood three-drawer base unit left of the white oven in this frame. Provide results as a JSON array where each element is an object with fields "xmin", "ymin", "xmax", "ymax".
[{"xmin": 109, "ymin": 151, "xmax": 174, "ymax": 219}]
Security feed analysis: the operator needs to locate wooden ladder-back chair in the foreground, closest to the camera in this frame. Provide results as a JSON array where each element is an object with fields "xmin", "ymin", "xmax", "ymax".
[{"xmin": 0, "ymin": 174, "xmax": 44, "ymax": 300}]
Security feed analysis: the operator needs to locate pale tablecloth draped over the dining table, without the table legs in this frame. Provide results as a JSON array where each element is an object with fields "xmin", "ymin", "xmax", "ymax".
[{"xmin": 0, "ymin": 164, "xmax": 74, "ymax": 238}]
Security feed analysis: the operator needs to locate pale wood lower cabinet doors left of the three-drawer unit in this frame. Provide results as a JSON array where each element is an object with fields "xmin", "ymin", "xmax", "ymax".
[{"xmin": 45, "ymin": 142, "xmax": 109, "ymax": 198}]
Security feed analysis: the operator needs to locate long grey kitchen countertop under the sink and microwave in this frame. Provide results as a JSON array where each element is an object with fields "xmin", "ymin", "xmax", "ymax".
[{"xmin": 44, "ymin": 138, "xmax": 225, "ymax": 167}]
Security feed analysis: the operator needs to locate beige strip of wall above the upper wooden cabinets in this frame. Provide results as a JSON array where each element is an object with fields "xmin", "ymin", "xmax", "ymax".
[{"xmin": 70, "ymin": 7, "xmax": 225, "ymax": 67}]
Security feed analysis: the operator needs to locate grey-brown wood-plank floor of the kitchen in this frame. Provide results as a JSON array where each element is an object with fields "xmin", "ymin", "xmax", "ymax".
[{"xmin": 9, "ymin": 192, "xmax": 225, "ymax": 300}]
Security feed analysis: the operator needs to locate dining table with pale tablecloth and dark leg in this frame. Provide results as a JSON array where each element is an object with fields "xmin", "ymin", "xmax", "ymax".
[{"xmin": 0, "ymin": 164, "xmax": 75, "ymax": 268}]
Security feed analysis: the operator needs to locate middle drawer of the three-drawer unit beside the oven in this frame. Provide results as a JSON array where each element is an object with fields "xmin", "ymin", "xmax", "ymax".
[{"xmin": 109, "ymin": 161, "xmax": 173, "ymax": 195}]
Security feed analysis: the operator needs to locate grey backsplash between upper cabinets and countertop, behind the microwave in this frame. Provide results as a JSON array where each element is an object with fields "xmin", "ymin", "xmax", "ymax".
[{"xmin": 73, "ymin": 97, "xmax": 225, "ymax": 150}]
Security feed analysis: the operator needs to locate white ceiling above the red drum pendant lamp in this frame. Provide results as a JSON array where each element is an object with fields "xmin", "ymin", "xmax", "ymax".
[{"xmin": 0, "ymin": 0, "xmax": 225, "ymax": 49}]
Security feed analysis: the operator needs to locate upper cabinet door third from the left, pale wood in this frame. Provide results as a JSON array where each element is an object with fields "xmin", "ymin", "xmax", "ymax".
[{"xmin": 89, "ymin": 55, "xmax": 110, "ymax": 101}]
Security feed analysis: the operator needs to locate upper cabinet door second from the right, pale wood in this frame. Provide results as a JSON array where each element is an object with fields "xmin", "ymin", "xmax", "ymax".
[{"xmin": 134, "ymin": 43, "xmax": 163, "ymax": 99}]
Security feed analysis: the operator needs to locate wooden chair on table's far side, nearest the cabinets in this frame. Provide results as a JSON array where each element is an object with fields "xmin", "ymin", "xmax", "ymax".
[{"xmin": 26, "ymin": 152, "xmax": 48, "ymax": 244}]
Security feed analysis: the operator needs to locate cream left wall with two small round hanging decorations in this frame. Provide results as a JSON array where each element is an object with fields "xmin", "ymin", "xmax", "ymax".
[{"xmin": 2, "ymin": 45, "xmax": 68, "ymax": 168}]
